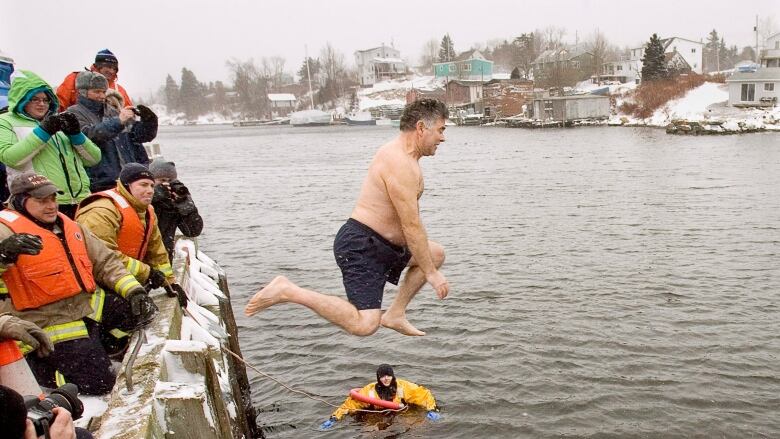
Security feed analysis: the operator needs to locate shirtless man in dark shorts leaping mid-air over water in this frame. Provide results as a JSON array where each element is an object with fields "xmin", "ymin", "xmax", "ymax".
[{"xmin": 244, "ymin": 99, "xmax": 450, "ymax": 336}]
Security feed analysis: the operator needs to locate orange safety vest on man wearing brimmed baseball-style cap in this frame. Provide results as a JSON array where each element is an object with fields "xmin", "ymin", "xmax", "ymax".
[{"xmin": 0, "ymin": 210, "xmax": 96, "ymax": 311}]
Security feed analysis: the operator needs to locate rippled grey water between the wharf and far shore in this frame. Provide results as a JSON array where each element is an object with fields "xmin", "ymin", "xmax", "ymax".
[{"xmin": 158, "ymin": 127, "xmax": 780, "ymax": 438}]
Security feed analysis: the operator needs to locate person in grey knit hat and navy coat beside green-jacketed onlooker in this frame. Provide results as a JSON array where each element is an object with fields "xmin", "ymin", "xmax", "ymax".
[{"xmin": 66, "ymin": 71, "xmax": 157, "ymax": 192}]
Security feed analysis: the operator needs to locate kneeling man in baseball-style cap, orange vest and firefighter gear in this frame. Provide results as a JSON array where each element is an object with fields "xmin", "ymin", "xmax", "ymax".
[{"xmin": 0, "ymin": 172, "xmax": 156, "ymax": 395}]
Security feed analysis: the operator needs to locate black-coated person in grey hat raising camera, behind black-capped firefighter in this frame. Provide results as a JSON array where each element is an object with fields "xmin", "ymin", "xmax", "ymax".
[{"xmin": 149, "ymin": 157, "xmax": 203, "ymax": 260}]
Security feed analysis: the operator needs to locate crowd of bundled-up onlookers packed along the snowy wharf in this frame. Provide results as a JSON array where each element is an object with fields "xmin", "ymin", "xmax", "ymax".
[{"xmin": 0, "ymin": 49, "xmax": 203, "ymax": 438}]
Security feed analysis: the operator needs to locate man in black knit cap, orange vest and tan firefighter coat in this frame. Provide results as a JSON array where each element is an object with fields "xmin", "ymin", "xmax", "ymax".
[{"xmin": 76, "ymin": 163, "xmax": 186, "ymax": 355}]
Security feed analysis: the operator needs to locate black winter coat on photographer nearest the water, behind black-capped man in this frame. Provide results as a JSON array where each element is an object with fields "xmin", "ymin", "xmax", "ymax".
[{"xmin": 152, "ymin": 184, "xmax": 203, "ymax": 259}]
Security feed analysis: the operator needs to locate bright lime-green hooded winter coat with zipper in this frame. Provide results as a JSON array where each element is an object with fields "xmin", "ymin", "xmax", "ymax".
[{"xmin": 0, "ymin": 71, "xmax": 100, "ymax": 204}]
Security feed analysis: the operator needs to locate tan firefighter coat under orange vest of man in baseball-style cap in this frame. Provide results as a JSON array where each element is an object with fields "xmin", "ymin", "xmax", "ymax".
[{"xmin": 0, "ymin": 209, "xmax": 140, "ymax": 332}]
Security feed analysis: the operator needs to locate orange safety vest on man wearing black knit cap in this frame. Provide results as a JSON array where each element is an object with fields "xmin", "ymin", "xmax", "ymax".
[{"xmin": 81, "ymin": 189, "xmax": 156, "ymax": 261}]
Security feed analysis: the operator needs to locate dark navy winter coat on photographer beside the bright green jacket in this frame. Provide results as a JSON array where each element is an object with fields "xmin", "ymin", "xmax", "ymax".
[{"xmin": 67, "ymin": 96, "xmax": 157, "ymax": 192}]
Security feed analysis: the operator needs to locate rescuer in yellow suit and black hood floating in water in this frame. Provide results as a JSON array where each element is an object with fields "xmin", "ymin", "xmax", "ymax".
[{"xmin": 320, "ymin": 364, "xmax": 441, "ymax": 430}]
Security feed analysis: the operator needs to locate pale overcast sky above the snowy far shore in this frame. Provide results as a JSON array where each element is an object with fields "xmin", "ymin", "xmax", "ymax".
[{"xmin": 0, "ymin": 0, "xmax": 780, "ymax": 96}]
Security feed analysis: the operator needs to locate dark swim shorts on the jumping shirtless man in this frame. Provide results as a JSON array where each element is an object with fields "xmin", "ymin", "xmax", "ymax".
[{"xmin": 333, "ymin": 218, "xmax": 412, "ymax": 310}]
